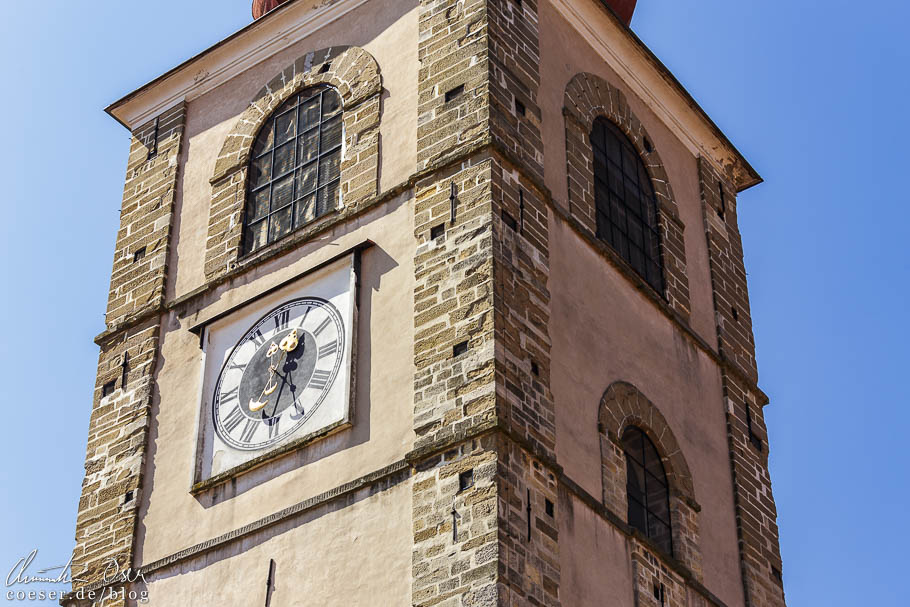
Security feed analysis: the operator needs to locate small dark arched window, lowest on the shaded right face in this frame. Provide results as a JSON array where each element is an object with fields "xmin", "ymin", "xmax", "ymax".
[{"xmin": 622, "ymin": 426, "xmax": 673, "ymax": 554}]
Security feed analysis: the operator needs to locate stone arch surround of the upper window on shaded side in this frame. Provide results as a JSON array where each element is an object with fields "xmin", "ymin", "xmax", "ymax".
[{"xmin": 563, "ymin": 72, "xmax": 690, "ymax": 318}]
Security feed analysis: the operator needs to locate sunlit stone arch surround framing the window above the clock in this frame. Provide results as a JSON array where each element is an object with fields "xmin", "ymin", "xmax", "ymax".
[{"xmin": 205, "ymin": 46, "xmax": 382, "ymax": 280}]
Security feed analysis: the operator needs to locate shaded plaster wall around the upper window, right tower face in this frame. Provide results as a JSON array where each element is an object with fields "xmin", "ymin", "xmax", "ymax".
[{"xmin": 538, "ymin": 0, "xmax": 717, "ymax": 347}]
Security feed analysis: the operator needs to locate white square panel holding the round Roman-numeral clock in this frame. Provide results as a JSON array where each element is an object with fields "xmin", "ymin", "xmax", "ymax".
[{"xmin": 197, "ymin": 252, "xmax": 357, "ymax": 482}]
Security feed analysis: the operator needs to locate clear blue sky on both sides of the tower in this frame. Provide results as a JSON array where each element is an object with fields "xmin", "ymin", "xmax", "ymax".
[{"xmin": 0, "ymin": 0, "xmax": 910, "ymax": 607}]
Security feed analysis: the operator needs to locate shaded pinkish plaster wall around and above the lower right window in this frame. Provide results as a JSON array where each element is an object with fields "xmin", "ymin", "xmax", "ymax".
[{"xmin": 549, "ymin": 210, "xmax": 742, "ymax": 605}]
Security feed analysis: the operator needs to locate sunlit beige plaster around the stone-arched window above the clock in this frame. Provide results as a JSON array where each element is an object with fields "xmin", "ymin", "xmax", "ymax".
[{"xmin": 167, "ymin": 0, "xmax": 419, "ymax": 299}]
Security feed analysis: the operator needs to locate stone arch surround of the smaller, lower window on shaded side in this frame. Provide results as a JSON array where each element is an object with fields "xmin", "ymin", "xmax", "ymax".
[{"xmin": 597, "ymin": 382, "xmax": 702, "ymax": 579}]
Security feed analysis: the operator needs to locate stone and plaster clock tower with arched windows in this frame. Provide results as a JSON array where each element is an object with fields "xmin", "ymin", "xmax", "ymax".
[{"xmin": 62, "ymin": 0, "xmax": 785, "ymax": 607}]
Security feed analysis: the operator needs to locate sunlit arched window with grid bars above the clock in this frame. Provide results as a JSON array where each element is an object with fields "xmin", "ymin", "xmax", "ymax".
[{"xmin": 243, "ymin": 86, "xmax": 343, "ymax": 253}]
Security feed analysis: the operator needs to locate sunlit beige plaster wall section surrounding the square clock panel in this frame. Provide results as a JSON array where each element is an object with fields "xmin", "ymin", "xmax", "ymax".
[{"xmin": 137, "ymin": 194, "xmax": 414, "ymax": 563}]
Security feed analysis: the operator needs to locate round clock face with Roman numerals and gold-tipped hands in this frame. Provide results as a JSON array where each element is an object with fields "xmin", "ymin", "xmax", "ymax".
[{"xmin": 212, "ymin": 297, "xmax": 345, "ymax": 451}]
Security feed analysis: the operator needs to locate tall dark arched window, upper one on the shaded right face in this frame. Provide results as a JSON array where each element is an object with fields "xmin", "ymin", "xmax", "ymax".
[{"xmin": 591, "ymin": 117, "xmax": 663, "ymax": 294}]
